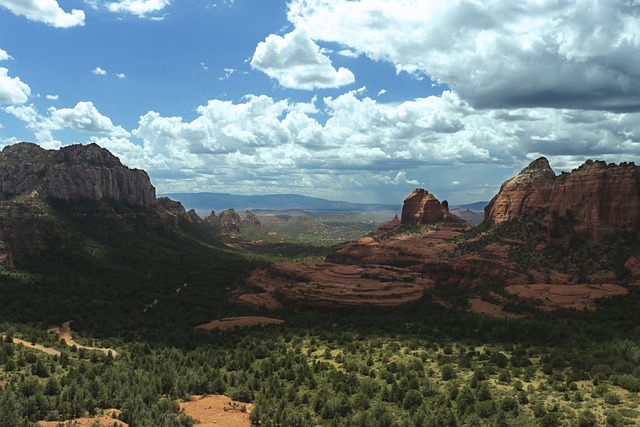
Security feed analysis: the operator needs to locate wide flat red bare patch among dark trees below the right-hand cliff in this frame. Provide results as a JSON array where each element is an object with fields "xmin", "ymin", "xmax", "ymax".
[{"xmin": 505, "ymin": 283, "xmax": 628, "ymax": 311}]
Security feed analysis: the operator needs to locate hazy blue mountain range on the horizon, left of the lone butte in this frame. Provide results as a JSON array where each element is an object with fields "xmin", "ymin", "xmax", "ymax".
[{"xmin": 164, "ymin": 193, "xmax": 402, "ymax": 213}]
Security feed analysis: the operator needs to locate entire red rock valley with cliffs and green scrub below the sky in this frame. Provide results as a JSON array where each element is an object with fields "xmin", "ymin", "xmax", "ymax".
[{"xmin": 0, "ymin": 143, "xmax": 640, "ymax": 427}]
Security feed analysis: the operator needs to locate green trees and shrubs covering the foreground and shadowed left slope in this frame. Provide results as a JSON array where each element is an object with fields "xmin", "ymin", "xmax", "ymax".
[{"xmin": 0, "ymin": 204, "xmax": 640, "ymax": 427}]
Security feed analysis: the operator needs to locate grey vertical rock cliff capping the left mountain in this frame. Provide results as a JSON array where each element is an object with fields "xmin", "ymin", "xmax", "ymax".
[{"xmin": 0, "ymin": 142, "xmax": 156, "ymax": 205}]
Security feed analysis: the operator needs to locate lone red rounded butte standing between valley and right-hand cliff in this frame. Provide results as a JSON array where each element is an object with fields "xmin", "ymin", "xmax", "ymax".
[{"xmin": 400, "ymin": 188, "xmax": 460, "ymax": 225}]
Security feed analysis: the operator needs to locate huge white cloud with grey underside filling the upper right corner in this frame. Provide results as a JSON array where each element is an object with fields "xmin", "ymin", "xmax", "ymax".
[{"xmin": 288, "ymin": 0, "xmax": 640, "ymax": 111}]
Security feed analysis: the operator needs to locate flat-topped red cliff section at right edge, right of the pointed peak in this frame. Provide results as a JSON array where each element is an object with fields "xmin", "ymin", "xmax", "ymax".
[{"xmin": 544, "ymin": 160, "xmax": 640, "ymax": 240}]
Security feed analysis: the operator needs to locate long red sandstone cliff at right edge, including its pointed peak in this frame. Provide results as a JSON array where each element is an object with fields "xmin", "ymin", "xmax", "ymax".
[{"xmin": 485, "ymin": 157, "xmax": 640, "ymax": 240}]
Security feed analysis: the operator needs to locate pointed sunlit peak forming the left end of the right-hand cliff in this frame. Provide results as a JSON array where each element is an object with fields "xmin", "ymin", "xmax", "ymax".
[{"xmin": 484, "ymin": 157, "xmax": 556, "ymax": 224}]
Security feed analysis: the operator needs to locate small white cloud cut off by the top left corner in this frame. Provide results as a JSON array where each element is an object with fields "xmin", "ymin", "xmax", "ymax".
[{"xmin": 0, "ymin": 0, "xmax": 85, "ymax": 28}]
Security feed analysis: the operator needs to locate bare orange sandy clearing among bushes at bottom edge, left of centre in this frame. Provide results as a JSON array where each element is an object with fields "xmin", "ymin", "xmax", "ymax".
[{"xmin": 180, "ymin": 395, "xmax": 253, "ymax": 427}]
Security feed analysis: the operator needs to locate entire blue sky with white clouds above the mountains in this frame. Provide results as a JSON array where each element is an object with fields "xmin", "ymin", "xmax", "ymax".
[{"xmin": 0, "ymin": 0, "xmax": 640, "ymax": 205}]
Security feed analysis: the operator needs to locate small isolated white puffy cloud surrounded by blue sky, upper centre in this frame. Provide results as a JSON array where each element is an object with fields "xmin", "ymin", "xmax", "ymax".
[{"xmin": 251, "ymin": 30, "xmax": 355, "ymax": 90}]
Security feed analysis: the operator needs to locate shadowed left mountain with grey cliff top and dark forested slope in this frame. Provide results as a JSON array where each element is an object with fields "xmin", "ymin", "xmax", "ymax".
[{"xmin": 0, "ymin": 143, "xmax": 260, "ymax": 334}]
